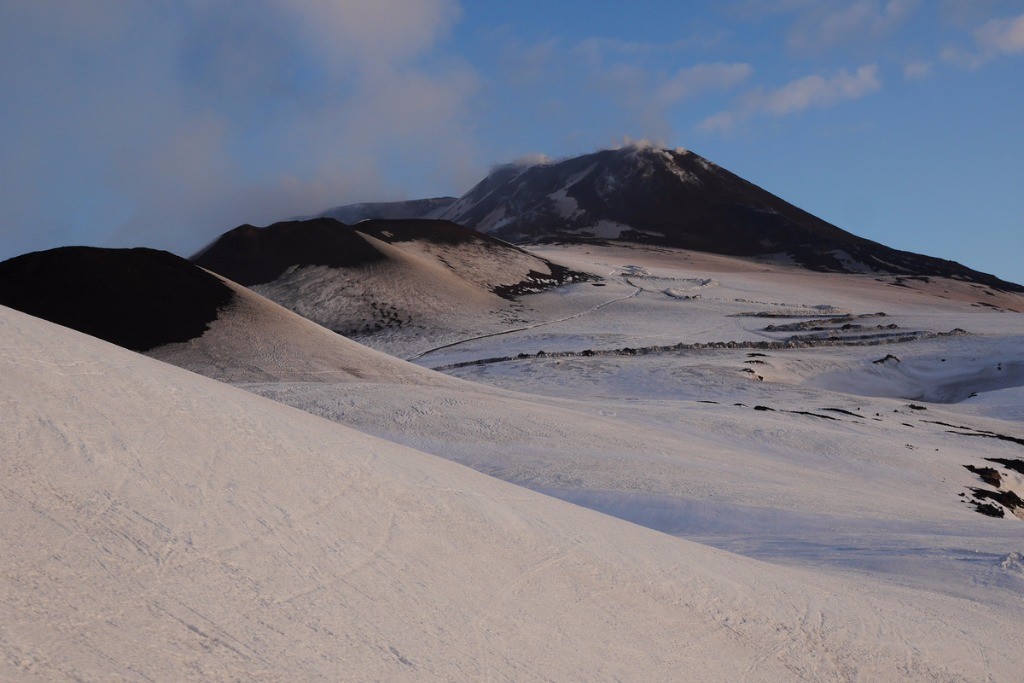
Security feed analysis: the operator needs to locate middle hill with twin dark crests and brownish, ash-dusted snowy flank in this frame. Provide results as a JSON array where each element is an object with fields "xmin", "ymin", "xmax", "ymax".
[{"xmin": 194, "ymin": 218, "xmax": 588, "ymax": 351}]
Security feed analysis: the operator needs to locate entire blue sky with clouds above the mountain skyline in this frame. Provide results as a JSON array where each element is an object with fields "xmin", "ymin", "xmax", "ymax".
[{"xmin": 0, "ymin": 0, "xmax": 1024, "ymax": 282}]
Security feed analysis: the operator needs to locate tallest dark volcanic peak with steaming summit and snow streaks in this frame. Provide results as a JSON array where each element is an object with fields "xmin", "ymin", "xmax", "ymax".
[{"xmin": 439, "ymin": 146, "xmax": 1024, "ymax": 291}]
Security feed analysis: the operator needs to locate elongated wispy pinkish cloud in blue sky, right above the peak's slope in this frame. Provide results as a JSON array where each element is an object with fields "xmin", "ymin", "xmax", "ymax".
[{"xmin": 698, "ymin": 65, "xmax": 882, "ymax": 132}]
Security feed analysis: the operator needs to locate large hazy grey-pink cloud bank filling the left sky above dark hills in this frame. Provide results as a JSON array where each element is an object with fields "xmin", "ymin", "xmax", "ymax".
[{"xmin": 0, "ymin": 0, "xmax": 481, "ymax": 258}]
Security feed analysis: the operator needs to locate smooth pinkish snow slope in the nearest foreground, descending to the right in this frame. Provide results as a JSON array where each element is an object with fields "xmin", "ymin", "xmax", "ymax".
[{"xmin": 8, "ymin": 308, "xmax": 1024, "ymax": 681}]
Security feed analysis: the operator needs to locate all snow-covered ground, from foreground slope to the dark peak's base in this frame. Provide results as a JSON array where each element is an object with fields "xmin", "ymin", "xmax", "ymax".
[{"xmin": 0, "ymin": 241, "xmax": 1024, "ymax": 681}]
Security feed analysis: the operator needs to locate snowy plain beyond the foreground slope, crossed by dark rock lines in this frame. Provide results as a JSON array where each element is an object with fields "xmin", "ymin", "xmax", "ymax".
[{"xmin": 207, "ymin": 246, "xmax": 1024, "ymax": 667}]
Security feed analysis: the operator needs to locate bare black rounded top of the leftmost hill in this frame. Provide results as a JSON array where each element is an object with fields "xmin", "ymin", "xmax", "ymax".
[{"xmin": 0, "ymin": 247, "xmax": 233, "ymax": 351}]
